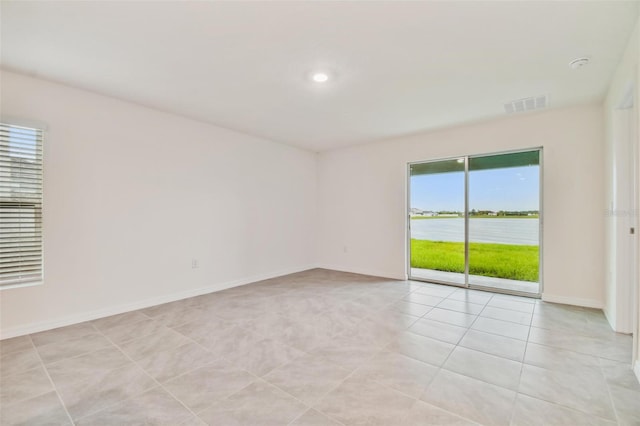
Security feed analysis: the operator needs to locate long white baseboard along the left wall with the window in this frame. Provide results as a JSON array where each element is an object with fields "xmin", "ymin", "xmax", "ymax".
[{"xmin": 0, "ymin": 265, "xmax": 316, "ymax": 339}]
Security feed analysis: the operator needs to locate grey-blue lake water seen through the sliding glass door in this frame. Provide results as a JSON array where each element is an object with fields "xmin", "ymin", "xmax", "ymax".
[{"xmin": 411, "ymin": 218, "xmax": 540, "ymax": 246}]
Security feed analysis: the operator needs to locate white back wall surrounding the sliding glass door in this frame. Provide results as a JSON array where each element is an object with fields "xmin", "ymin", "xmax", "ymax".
[{"xmin": 318, "ymin": 105, "xmax": 604, "ymax": 307}]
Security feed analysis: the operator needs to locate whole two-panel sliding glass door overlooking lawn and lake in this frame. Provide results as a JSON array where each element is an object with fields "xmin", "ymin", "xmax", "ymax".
[{"xmin": 409, "ymin": 149, "xmax": 541, "ymax": 296}]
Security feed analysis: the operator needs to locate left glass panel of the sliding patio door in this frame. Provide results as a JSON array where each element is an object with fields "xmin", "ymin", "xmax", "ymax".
[{"xmin": 409, "ymin": 158, "xmax": 466, "ymax": 286}]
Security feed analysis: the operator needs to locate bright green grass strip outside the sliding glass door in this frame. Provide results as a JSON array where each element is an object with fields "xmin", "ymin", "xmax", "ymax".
[{"xmin": 411, "ymin": 239, "xmax": 538, "ymax": 282}]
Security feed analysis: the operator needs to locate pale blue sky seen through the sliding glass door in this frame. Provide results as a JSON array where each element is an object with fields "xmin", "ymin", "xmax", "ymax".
[{"xmin": 411, "ymin": 166, "xmax": 540, "ymax": 212}]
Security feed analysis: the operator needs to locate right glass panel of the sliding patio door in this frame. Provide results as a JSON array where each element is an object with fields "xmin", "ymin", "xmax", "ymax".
[{"xmin": 468, "ymin": 150, "xmax": 540, "ymax": 295}]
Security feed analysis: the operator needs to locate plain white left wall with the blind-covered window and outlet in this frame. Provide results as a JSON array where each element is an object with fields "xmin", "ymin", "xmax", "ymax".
[{"xmin": 0, "ymin": 72, "xmax": 317, "ymax": 338}]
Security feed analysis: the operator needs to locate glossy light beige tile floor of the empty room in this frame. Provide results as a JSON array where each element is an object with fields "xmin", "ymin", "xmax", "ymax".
[{"xmin": 0, "ymin": 269, "xmax": 640, "ymax": 426}]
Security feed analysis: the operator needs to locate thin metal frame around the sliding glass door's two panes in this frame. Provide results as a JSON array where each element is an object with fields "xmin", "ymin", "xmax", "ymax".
[{"xmin": 405, "ymin": 146, "xmax": 544, "ymax": 299}]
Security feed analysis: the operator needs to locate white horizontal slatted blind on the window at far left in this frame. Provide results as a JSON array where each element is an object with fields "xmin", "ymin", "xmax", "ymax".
[{"xmin": 0, "ymin": 123, "xmax": 42, "ymax": 287}]
